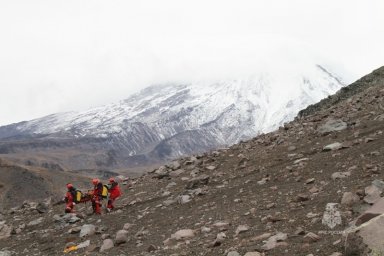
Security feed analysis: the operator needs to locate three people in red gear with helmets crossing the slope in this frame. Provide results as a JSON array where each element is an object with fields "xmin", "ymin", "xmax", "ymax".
[{"xmin": 64, "ymin": 178, "xmax": 121, "ymax": 214}]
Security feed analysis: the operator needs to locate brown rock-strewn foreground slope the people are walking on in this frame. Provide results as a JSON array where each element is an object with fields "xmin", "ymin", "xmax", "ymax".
[{"xmin": 0, "ymin": 67, "xmax": 384, "ymax": 256}]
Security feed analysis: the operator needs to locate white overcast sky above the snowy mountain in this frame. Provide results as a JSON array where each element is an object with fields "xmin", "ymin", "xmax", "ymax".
[{"xmin": 0, "ymin": 0, "xmax": 384, "ymax": 125}]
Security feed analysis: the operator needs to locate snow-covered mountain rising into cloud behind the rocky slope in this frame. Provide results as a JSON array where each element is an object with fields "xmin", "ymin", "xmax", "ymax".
[{"xmin": 0, "ymin": 65, "xmax": 343, "ymax": 168}]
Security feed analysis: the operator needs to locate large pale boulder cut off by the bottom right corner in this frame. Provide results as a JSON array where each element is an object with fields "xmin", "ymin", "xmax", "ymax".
[{"xmin": 345, "ymin": 214, "xmax": 384, "ymax": 255}]
